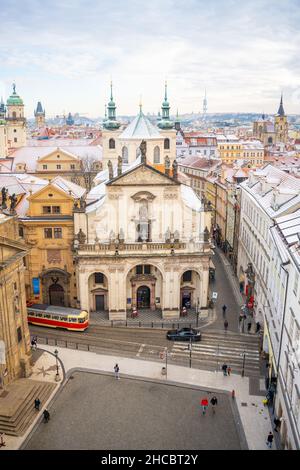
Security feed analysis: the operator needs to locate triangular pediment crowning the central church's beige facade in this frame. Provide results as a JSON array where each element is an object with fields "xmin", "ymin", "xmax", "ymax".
[{"xmin": 107, "ymin": 165, "xmax": 179, "ymax": 186}]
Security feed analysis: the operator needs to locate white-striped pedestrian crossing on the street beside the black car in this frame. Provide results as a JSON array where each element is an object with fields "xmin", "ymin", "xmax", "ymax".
[{"xmin": 170, "ymin": 332, "xmax": 260, "ymax": 377}]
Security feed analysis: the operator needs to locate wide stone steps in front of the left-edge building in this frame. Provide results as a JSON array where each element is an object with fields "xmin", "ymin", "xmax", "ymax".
[{"xmin": 0, "ymin": 379, "xmax": 56, "ymax": 436}]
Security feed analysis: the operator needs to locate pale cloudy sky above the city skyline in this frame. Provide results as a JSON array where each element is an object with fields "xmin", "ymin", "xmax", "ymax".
[{"xmin": 0, "ymin": 0, "xmax": 300, "ymax": 117}]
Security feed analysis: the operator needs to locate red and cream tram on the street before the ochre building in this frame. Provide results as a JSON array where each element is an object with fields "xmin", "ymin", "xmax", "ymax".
[{"xmin": 27, "ymin": 304, "xmax": 89, "ymax": 331}]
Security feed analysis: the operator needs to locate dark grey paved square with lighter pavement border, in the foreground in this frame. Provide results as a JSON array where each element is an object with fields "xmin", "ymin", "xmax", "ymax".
[{"xmin": 26, "ymin": 372, "xmax": 241, "ymax": 450}]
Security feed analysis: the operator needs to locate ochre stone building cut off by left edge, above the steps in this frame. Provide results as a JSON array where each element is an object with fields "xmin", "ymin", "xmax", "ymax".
[{"xmin": 0, "ymin": 214, "xmax": 31, "ymax": 385}]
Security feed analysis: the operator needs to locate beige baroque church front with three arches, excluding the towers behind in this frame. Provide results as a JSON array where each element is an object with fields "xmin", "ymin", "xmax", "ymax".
[{"xmin": 74, "ymin": 152, "xmax": 211, "ymax": 319}]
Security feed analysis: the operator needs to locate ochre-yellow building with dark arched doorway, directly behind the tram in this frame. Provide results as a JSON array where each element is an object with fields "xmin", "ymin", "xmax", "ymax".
[{"xmin": 20, "ymin": 177, "xmax": 86, "ymax": 307}]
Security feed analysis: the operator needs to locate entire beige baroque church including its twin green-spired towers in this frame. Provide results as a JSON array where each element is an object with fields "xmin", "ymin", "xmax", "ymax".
[{"xmin": 74, "ymin": 87, "xmax": 212, "ymax": 320}]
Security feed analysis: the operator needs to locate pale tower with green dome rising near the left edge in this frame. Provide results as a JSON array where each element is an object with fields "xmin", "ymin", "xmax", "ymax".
[{"xmin": 6, "ymin": 84, "xmax": 26, "ymax": 148}]
